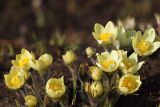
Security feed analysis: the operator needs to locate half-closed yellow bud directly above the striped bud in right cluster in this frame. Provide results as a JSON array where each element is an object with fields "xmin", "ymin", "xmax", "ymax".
[{"xmin": 89, "ymin": 66, "xmax": 103, "ymax": 81}]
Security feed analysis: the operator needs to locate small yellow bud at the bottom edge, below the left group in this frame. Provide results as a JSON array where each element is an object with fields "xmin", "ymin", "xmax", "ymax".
[{"xmin": 24, "ymin": 95, "xmax": 37, "ymax": 107}]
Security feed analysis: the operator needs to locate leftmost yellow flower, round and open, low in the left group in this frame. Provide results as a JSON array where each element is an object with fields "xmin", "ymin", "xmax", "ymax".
[{"xmin": 4, "ymin": 71, "xmax": 25, "ymax": 90}]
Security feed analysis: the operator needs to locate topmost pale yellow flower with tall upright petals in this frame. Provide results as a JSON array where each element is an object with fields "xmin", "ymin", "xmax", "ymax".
[{"xmin": 92, "ymin": 21, "xmax": 117, "ymax": 44}]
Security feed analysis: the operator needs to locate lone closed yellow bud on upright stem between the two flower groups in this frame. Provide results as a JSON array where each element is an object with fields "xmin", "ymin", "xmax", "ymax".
[{"xmin": 62, "ymin": 50, "xmax": 76, "ymax": 65}]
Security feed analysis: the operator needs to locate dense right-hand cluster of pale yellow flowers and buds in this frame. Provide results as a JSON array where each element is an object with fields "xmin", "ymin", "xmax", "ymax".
[{"xmin": 85, "ymin": 21, "xmax": 160, "ymax": 102}]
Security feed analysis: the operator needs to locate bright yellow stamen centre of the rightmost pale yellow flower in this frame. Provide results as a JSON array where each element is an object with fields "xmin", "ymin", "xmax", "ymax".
[{"xmin": 137, "ymin": 40, "xmax": 151, "ymax": 53}]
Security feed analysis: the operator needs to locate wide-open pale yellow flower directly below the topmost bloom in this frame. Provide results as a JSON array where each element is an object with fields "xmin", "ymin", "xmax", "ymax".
[{"xmin": 96, "ymin": 50, "xmax": 119, "ymax": 72}]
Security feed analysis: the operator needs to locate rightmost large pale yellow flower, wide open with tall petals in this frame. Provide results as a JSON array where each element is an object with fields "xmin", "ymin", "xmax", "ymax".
[{"xmin": 132, "ymin": 28, "xmax": 160, "ymax": 56}]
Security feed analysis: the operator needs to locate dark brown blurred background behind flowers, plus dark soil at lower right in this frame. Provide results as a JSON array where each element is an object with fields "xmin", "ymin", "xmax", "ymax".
[{"xmin": 0, "ymin": 0, "xmax": 160, "ymax": 107}]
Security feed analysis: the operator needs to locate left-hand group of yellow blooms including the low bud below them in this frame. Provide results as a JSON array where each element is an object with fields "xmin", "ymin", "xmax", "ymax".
[{"xmin": 4, "ymin": 49, "xmax": 65, "ymax": 107}]
